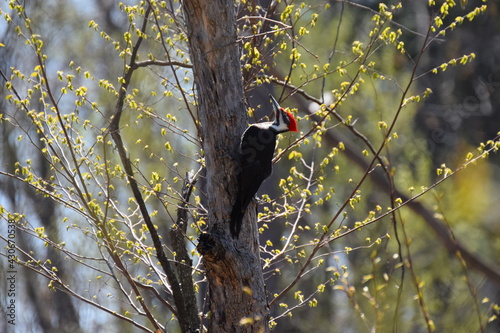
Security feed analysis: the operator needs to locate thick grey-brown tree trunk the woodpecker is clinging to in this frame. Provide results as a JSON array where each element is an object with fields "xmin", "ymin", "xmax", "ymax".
[{"xmin": 183, "ymin": 0, "xmax": 269, "ymax": 332}]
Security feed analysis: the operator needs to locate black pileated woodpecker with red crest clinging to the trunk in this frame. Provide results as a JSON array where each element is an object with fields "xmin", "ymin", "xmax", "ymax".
[{"xmin": 230, "ymin": 95, "xmax": 297, "ymax": 238}]
